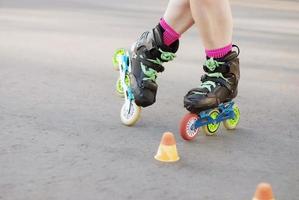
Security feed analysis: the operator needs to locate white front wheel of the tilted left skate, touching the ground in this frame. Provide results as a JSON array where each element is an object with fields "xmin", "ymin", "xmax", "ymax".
[{"xmin": 120, "ymin": 102, "xmax": 141, "ymax": 126}]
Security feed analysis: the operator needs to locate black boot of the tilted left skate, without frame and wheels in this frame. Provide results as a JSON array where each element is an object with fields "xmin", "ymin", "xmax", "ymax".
[{"xmin": 130, "ymin": 25, "xmax": 179, "ymax": 107}]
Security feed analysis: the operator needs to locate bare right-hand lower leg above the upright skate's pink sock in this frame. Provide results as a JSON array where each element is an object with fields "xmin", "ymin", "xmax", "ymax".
[{"xmin": 190, "ymin": 0, "xmax": 233, "ymax": 49}]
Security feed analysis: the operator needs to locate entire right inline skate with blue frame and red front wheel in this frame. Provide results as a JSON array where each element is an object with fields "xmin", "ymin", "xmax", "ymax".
[{"xmin": 180, "ymin": 45, "xmax": 240, "ymax": 140}]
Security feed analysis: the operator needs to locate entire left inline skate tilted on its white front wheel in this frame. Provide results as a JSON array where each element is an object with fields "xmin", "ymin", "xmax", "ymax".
[{"xmin": 113, "ymin": 25, "xmax": 179, "ymax": 126}]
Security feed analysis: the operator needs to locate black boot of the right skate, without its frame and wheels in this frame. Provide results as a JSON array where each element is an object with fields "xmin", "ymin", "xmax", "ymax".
[{"xmin": 184, "ymin": 45, "xmax": 240, "ymax": 113}]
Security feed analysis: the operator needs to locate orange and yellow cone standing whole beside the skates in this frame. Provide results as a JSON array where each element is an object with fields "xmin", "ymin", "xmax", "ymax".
[{"xmin": 155, "ymin": 132, "xmax": 180, "ymax": 162}]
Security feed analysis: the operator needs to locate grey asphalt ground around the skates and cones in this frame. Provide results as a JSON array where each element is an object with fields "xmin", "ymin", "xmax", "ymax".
[{"xmin": 0, "ymin": 0, "xmax": 299, "ymax": 200}]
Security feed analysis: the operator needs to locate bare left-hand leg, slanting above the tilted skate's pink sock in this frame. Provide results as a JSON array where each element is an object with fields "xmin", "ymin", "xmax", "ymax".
[{"xmin": 163, "ymin": 0, "xmax": 194, "ymax": 34}]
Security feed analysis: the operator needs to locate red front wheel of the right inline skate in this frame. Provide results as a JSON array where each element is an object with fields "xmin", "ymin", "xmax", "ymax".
[{"xmin": 180, "ymin": 113, "xmax": 199, "ymax": 140}]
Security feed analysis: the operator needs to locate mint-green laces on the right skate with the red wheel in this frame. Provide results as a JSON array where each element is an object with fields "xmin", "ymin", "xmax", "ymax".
[{"xmin": 195, "ymin": 58, "xmax": 227, "ymax": 94}]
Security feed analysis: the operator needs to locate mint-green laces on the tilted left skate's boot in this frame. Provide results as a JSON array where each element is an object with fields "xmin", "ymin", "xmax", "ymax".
[{"xmin": 141, "ymin": 49, "xmax": 176, "ymax": 81}]
